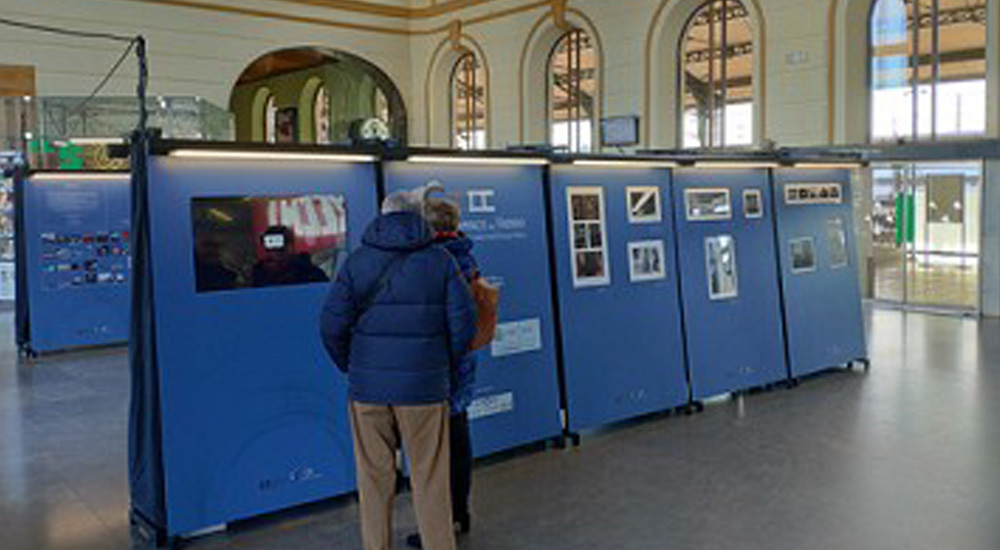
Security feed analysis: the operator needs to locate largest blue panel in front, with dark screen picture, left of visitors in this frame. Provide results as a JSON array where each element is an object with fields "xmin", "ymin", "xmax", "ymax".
[{"xmin": 149, "ymin": 156, "xmax": 378, "ymax": 536}]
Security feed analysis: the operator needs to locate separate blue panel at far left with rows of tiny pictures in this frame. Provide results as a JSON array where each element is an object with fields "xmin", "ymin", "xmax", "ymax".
[{"xmin": 18, "ymin": 173, "xmax": 132, "ymax": 353}]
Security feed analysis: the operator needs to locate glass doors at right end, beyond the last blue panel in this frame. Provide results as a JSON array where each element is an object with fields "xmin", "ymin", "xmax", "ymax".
[{"xmin": 868, "ymin": 162, "xmax": 983, "ymax": 313}]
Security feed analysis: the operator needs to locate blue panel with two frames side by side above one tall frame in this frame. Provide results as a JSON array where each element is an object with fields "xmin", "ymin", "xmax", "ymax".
[{"xmin": 674, "ymin": 169, "xmax": 788, "ymax": 399}]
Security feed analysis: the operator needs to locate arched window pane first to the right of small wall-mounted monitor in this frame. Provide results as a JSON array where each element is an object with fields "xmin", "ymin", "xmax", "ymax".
[{"xmin": 678, "ymin": 0, "xmax": 754, "ymax": 147}]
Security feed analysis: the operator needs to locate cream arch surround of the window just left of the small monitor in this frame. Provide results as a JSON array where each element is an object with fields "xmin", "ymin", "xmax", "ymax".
[{"xmin": 518, "ymin": 7, "xmax": 606, "ymax": 150}]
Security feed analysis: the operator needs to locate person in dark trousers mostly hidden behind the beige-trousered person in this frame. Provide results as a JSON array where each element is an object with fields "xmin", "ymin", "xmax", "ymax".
[{"xmin": 406, "ymin": 198, "xmax": 479, "ymax": 548}]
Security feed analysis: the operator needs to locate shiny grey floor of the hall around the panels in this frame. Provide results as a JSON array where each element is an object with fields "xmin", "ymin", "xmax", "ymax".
[{"xmin": 0, "ymin": 310, "xmax": 1000, "ymax": 550}]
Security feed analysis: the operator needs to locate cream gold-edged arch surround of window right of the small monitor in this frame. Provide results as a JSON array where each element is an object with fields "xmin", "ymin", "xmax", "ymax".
[{"xmin": 642, "ymin": 0, "xmax": 767, "ymax": 148}]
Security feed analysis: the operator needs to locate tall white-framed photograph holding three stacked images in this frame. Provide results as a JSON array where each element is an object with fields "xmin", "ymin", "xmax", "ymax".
[{"xmin": 566, "ymin": 187, "xmax": 611, "ymax": 288}]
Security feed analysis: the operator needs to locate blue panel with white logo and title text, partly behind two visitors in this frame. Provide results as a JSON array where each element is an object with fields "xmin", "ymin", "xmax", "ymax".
[{"xmin": 385, "ymin": 159, "xmax": 562, "ymax": 456}]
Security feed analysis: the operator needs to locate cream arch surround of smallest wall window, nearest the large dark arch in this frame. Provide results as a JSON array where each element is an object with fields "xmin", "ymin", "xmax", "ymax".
[{"xmin": 424, "ymin": 32, "xmax": 493, "ymax": 148}]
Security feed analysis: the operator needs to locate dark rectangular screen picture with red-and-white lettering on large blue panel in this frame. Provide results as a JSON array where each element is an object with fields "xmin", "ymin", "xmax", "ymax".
[{"xmin": 191, "ymin": 195, "xmax": 347, "ymax": 293}]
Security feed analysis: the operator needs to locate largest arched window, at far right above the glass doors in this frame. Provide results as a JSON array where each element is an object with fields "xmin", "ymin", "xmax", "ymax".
[{"xmin": 869, "ymin": 0, "xmax": 986, "ymax": 141}]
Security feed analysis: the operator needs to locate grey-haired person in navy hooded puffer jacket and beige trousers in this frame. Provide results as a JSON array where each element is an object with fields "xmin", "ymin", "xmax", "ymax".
[{"xmin": 321, "ymin": 193, "xmax": 476, "ymax": 550}]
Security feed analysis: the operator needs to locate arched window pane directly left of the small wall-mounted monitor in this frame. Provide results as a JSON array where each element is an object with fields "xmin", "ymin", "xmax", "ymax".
[{"xmin": 548, "ymin": 29, "xmax": 597, "ymax": 153}]
